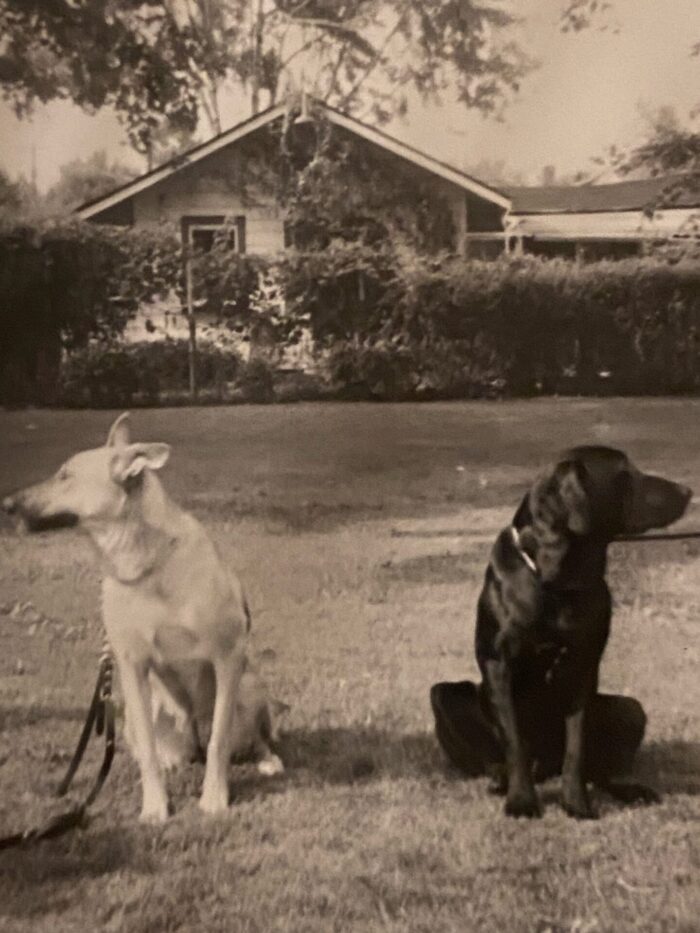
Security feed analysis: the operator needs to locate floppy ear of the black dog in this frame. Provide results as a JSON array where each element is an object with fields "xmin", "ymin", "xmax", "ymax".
[{"xmin": 529, "ymin": 459, "xmax": 591, "ymax": 535}]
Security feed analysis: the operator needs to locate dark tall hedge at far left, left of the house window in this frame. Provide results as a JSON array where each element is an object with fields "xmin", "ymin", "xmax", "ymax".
[{"xmin": 0, "ymin": 221, "xmax": 182, "ymax": 404}]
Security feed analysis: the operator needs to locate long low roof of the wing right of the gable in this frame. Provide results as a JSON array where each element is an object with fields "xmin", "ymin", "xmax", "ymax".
[{"xmin": 504, "ymin": 175, "xmax": 700, "ymax": 214}]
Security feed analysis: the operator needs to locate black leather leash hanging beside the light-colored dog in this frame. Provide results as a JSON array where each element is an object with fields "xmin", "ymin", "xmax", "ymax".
[{"xmin": 0, "ymin": 649, "xmax": 115, "ymax": 850}]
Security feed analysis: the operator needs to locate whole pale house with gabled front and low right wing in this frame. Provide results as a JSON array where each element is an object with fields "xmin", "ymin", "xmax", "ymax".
[{"xmin": 77, "ymin": 101, "xmax": 700, "ymax": 337}]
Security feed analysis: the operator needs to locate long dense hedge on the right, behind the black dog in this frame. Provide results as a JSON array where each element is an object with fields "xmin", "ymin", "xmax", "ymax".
[{"xmin": 278, "ymin": 244, "xmax": 700, "ymax": 398}]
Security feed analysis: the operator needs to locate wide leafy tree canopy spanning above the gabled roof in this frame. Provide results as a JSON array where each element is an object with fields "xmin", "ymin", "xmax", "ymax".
[{"xmin": 0, "ymin": 0, "xmax": 528, "ymax": 146}]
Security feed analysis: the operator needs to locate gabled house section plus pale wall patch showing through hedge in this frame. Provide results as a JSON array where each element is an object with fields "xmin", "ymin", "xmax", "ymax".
[{"xmin": 77, "ymin": 101, "xmax": 510, "ymax": 338}]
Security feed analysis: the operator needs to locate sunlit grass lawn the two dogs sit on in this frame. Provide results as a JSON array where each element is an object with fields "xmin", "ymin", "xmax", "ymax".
[{"xmin": 0, "ymin": 399, "xmax": 700, "ymax": 933}]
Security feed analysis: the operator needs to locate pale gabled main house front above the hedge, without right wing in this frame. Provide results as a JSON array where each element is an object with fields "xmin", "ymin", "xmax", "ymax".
[{"xmin": 77, "ymin": 102, "xmax": 510, "ymax": 255}]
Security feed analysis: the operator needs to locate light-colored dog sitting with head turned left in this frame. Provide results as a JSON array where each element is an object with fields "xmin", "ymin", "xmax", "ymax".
[{"xmin": 3, "ymin": 414, "xmax": 283, "ymax": 822}]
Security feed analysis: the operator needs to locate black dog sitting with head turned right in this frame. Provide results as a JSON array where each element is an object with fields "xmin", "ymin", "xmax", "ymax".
[{"xmin": 430, "ymin": 447, "xmax": 692, "ymax": 818}]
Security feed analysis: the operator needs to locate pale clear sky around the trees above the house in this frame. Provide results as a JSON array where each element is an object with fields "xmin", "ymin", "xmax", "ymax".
[{"xmin": 0, "ymin": 0, "xmax": 700, "ymax": 190}]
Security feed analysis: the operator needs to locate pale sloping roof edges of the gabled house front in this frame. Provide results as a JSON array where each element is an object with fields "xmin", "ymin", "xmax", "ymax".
[{"xmin": 76, "ymin": 100, "xmax": 511, "ymax": 220}]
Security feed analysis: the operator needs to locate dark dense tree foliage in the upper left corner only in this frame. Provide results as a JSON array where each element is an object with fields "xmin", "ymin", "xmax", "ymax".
[{"xmin": 0, "ymin": 0, "xmax": 198, "ymax": 152}]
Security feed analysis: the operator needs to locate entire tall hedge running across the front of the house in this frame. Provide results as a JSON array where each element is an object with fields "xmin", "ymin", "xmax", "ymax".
[{"xmin": 0, "ymin": 224, "xmax": 700, "ymax": 404}]
